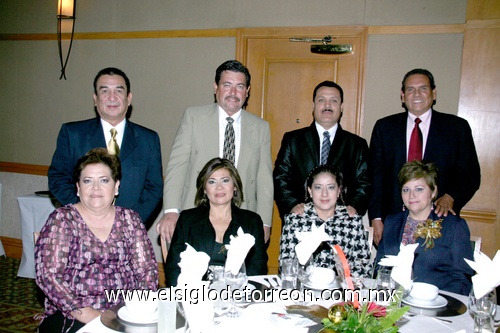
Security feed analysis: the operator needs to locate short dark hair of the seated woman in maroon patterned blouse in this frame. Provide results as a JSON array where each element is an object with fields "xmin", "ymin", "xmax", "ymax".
[{"xmin": 73, "ymin": 148, "xmax": 122, "ymax": 183}]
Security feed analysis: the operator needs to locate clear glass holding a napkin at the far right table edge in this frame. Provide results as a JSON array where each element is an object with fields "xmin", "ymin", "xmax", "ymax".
[{"xmin": 467, "ymin": 289, "xmax": 497, "ymax": 333}]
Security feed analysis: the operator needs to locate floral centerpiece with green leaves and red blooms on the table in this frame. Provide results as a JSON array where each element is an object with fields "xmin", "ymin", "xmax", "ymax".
[{"xmin": 321, "ymin": 301, "xmax": 410, "ymax": 333}]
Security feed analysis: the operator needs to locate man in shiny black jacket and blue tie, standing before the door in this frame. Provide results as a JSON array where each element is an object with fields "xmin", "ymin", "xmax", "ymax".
[{"xmin": 273, "ymin": 81, "xmax": 370, "ymax": 221}]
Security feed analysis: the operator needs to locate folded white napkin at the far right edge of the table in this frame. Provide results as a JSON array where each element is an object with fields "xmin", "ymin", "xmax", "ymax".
[{"xmin": 464, "ymin": 250, "xmax": 500, "ymax": 298}]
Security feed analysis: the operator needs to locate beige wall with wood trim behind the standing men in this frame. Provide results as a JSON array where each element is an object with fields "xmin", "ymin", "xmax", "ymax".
[{"xmin": 0, "ymin": 0, "xmax": 467, "ymax": 246}]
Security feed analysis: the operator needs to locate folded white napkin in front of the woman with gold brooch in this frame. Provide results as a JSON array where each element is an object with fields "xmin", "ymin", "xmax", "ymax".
[{"xmin": 379, "ymin": 243, "xmax": 418, "ymax": 290}]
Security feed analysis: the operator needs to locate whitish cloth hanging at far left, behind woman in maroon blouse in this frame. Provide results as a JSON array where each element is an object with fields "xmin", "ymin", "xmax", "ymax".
[{"xmin": 17, "ymin": 194, "xmax": 55, "ymax": 279}]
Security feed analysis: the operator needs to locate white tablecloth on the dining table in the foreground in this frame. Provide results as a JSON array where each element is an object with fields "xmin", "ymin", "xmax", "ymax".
[{"xmin": 78, "ymin": 276, "xmax": 473, "ymax": 333}]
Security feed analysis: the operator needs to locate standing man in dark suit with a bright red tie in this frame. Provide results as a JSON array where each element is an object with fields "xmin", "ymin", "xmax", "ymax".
[{"xmin": 368, "ymin": 69, "xmax": 481, "ymax": 244}]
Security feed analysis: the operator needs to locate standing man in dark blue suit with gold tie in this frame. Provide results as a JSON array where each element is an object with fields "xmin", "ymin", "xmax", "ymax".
[{"xmin": 48, "ymin": 68, "xmax": 163, "ymax": 226}]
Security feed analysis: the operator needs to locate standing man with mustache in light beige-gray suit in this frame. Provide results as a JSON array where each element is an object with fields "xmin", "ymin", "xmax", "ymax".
[{"xmin": 156, "ymin": 60, "xmax": 273, "ymax": 243}]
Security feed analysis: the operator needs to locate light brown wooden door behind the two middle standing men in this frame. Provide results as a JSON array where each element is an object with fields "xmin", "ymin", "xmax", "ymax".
[{"xmin": 238, "ymin": 27, "xmax": 366, "ymax": 273}]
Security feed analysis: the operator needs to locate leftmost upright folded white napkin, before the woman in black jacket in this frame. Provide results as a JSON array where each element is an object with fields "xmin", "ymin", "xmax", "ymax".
[{"xmin": 177, "ymin": 243, "xmax": 210, "ymax": 286}]
